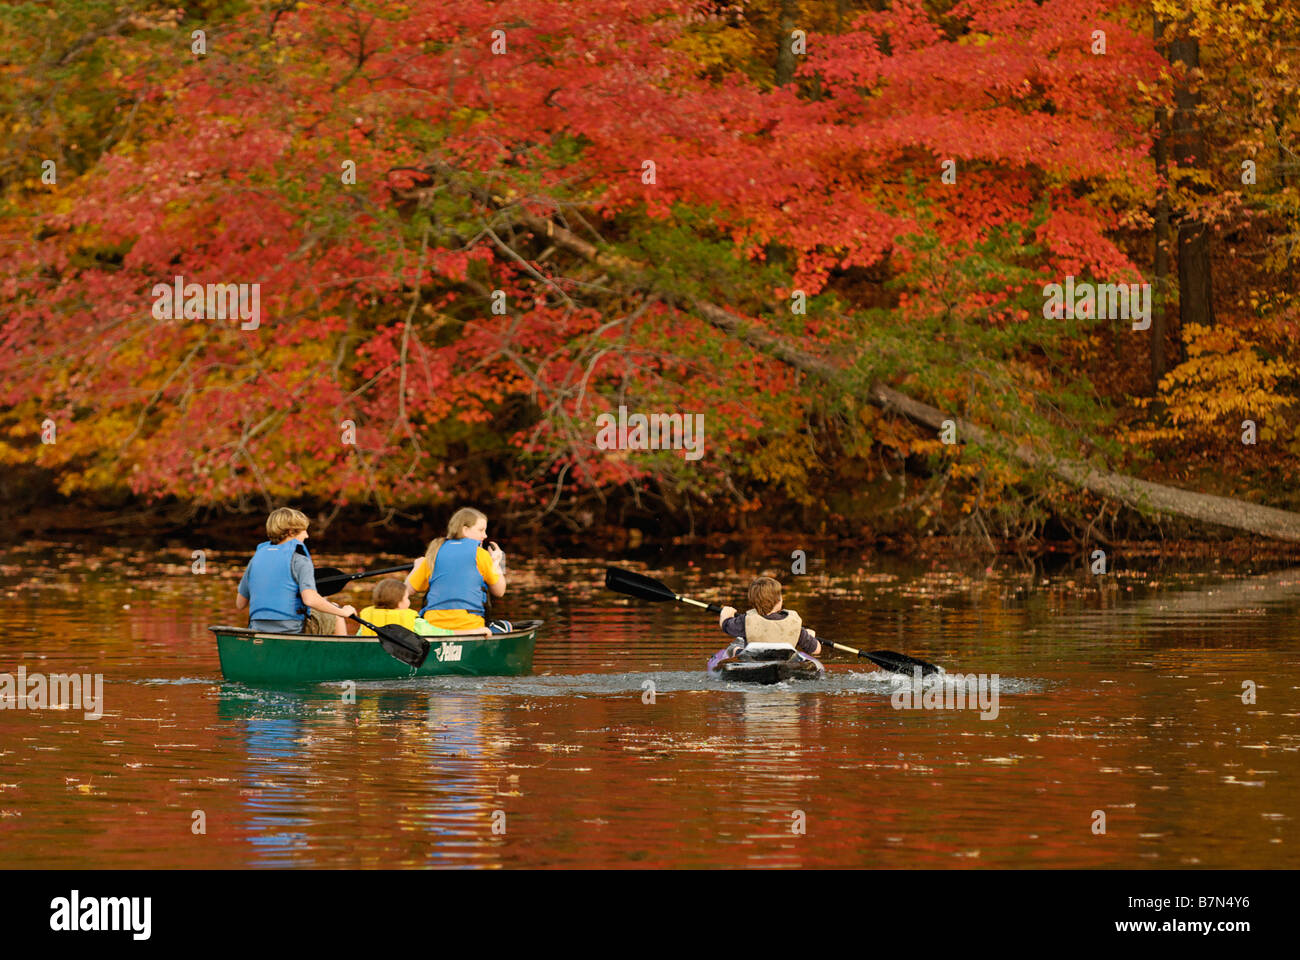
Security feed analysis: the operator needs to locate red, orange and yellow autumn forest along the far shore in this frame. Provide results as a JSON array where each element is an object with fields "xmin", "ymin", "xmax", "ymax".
[{"xmin": 0, "ymin": 0, "xmax": 1300, "ymax": 546}]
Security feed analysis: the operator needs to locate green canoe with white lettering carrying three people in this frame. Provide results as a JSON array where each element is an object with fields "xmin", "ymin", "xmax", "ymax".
[{"xmin": 208, "ymin": 620, "xmax": 542, "ymax": 684}]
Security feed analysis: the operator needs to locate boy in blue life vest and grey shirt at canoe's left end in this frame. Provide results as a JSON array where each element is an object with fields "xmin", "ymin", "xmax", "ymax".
[{"xmin": 235, "ymin": 507, "xmax": 356, "ymax": 636}]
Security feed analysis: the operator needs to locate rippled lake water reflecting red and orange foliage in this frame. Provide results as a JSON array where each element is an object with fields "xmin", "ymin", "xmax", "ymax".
[{"xmin": 0, "ymin": 542, "xmax": 1300, "ymax": 869}]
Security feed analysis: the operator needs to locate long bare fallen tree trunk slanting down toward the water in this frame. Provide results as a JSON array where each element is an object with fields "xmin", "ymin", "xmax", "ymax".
[{"xmin": 439, "ymin": 174, "xmax": 1300, "ymax": 542}]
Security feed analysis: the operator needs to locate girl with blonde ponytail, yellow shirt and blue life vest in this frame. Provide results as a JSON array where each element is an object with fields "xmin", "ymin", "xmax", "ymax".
[{"xmin": 406, "ymin": 507, "xmax": 510, "ymax": 635}]
